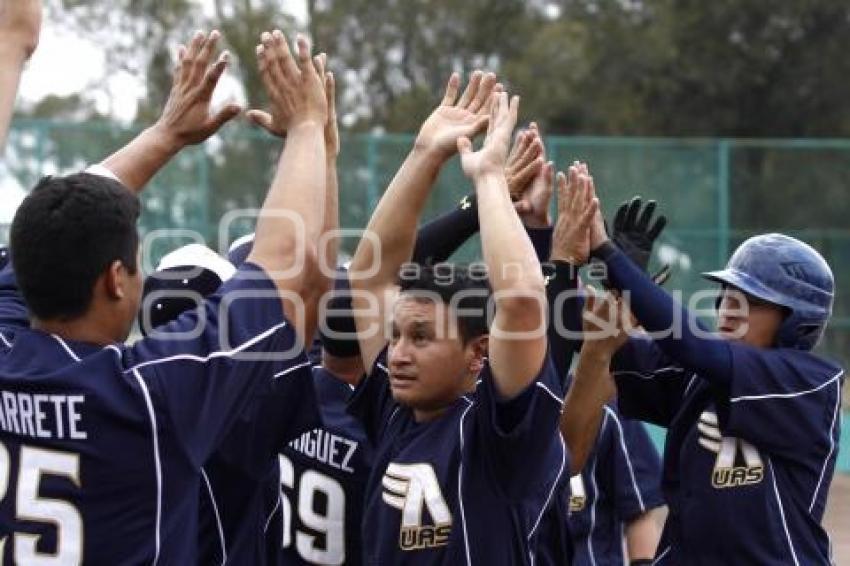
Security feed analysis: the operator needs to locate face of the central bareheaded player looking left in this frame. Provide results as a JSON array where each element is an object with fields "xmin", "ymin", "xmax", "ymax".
[{"xmin": 387, "ymin": 295, "xmax": 480, "ymax": 418}]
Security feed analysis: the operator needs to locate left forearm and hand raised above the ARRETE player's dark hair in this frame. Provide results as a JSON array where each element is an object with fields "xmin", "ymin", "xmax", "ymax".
[{"xmin": 101, "ymin": 30, "xmax": 241, "ymax": 193}]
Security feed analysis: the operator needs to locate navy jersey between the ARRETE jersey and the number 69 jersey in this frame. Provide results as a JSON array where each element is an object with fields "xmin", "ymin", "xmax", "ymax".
[{"xmin": 199, "ymin": 360, "xmax": 321, "ymax": 566}]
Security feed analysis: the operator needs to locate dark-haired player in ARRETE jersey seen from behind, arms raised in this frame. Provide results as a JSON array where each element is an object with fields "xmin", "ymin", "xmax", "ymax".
[{"xmin": 0, "ymin": 28, "xmax": 326, "ymax": 564}]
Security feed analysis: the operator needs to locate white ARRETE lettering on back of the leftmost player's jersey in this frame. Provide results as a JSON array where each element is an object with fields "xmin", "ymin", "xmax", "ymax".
[{"xmin": 0, "ymin": 391, "xmax": 88, "ymax": 440}]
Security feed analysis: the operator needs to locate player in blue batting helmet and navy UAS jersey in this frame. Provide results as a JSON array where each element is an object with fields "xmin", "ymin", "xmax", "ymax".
[{"xmin": 587, "ymin": 177, "xmax": 844, "ymax": 565}]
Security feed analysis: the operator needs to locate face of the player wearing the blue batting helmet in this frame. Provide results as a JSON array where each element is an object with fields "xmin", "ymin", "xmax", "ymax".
[{"xmin": 717, "ymin": 288, "xmax": 785, "ymax": 348}]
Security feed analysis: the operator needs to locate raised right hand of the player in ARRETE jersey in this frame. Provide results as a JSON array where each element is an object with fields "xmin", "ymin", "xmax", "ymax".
[{"xmin": 247, "ymin": 30, "xmax": 329, "ymax": 136}]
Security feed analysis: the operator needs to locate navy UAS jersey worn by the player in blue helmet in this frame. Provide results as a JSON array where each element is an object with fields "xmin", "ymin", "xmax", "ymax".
[{"xmin": 614, "ymin": 338, "xmax": 843, "ymax": 565}]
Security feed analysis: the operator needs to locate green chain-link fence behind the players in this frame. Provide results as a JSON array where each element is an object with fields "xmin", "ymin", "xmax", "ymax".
[{"xmin": 0, "ymin": 120, "xmax": 850, "ymax": 372}]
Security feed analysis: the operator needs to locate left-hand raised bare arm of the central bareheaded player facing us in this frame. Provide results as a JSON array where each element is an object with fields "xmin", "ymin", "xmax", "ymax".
[{"xmin": 349, "ymin": 71, "xmax": 497, "ymax": 371}]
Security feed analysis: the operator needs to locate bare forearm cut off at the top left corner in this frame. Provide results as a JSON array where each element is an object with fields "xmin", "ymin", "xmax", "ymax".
[{"xmin": 0, "ymin": 0, "xmax": 41, "ymax": 150}]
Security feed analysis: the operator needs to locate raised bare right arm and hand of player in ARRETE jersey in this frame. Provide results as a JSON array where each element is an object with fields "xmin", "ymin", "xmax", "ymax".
[{"xmin": 243, "ymin": 30, "xmax": 328, "ymax": 344}]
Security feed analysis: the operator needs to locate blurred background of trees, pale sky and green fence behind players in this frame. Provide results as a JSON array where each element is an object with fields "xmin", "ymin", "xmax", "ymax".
[{"xmin": 0, "ymin": 0, "xmax": 850, "ymax": 548}]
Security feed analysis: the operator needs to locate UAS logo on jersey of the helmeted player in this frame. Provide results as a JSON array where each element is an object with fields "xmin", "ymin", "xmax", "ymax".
[{"xmin": 697, "ymin": 411, "xmax": 764, "ymax": 489}]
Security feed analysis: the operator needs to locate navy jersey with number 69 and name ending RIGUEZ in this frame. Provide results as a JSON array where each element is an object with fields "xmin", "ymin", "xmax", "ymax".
[{"xmin": 267, "ymin": 366, "xmax": 372, "ymax": 566}]
